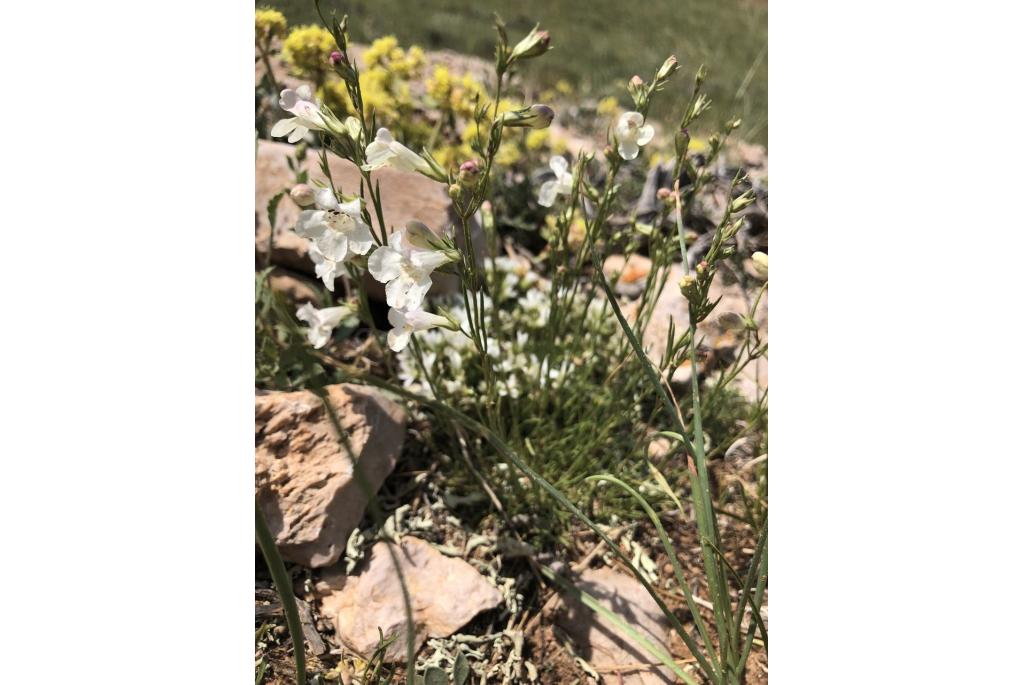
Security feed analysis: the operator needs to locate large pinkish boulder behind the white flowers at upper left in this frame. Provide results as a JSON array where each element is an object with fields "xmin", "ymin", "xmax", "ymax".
[{"xmin": 256, "ymin": 140, "xmax": 484, "ymax": 299}]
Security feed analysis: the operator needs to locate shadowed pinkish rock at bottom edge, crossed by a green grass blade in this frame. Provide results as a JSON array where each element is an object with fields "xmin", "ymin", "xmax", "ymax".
[{"xmin": 556, "ymin": 568, "xmax": 676, "ymax": 685}]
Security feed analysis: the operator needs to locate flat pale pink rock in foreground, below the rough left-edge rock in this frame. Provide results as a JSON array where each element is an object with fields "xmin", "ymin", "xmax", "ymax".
[{"xmin": 316, "ymin": 538, "xmax": 502, "ymax": 661}]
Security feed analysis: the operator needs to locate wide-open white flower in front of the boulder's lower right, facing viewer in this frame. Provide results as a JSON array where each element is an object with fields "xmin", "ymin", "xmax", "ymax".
[{"xmin": 367, "ymin": 221, "xmax": 453, "ymax": 310}]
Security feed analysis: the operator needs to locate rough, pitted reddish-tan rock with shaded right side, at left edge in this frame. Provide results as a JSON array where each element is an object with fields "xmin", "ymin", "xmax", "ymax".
[{"xmin": 256, "ymin": 384, "xmax": 406, "ymax": 567}]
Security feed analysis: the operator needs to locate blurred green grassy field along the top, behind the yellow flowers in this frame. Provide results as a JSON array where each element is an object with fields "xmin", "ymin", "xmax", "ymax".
[{"xmin": 256, "ymin": 0, "xmax": 768, "ymax": 145}]
